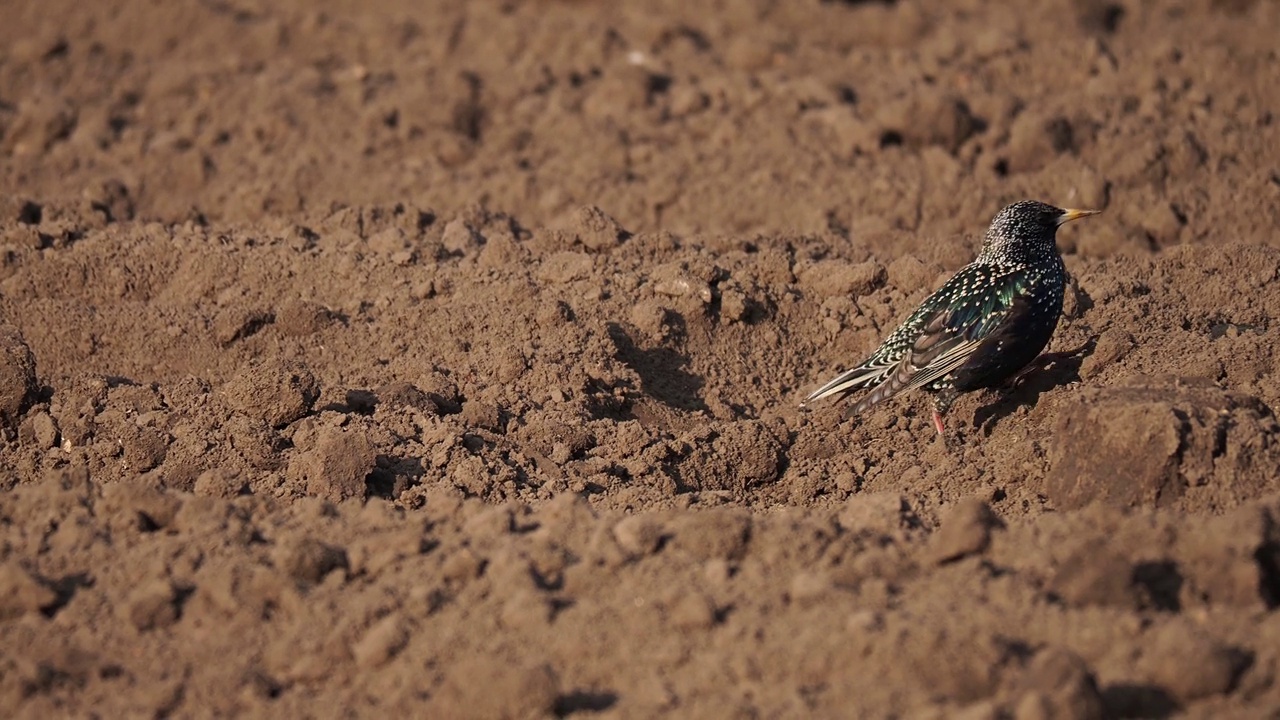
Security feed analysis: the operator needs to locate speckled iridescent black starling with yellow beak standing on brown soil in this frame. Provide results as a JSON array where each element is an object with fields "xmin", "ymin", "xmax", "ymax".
[{"xmin": 805, "ymin": 200, "xmax": 1098, "ymax": 436}]
